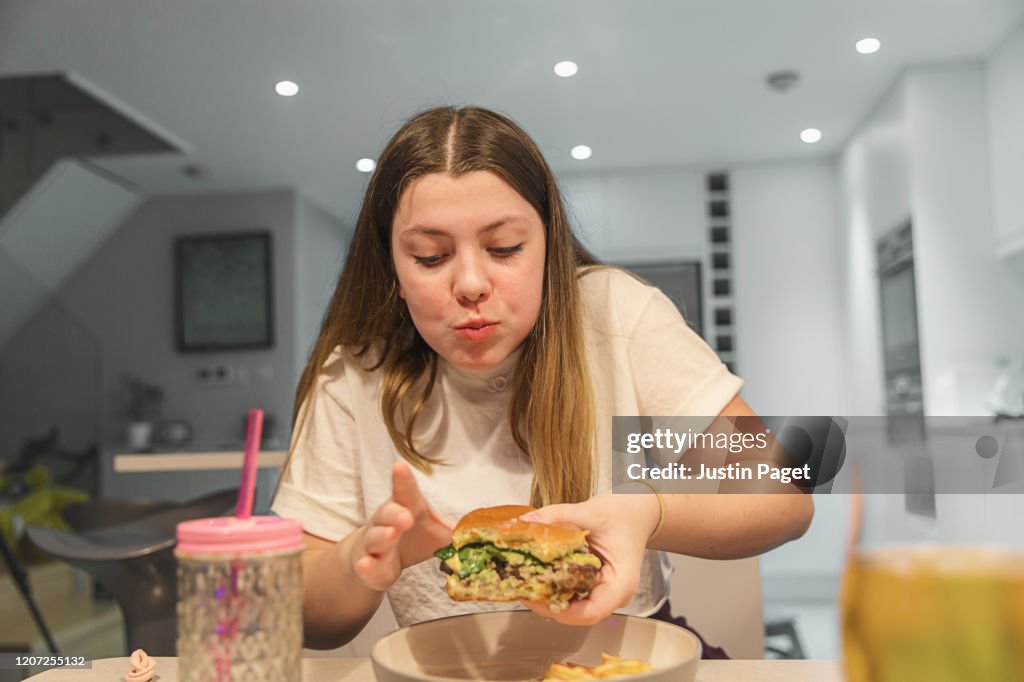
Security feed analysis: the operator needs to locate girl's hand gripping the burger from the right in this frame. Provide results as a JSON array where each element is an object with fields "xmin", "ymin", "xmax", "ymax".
[{"xmin": 520, "ymin": 493, "xmax": 658, "ymax": 625}]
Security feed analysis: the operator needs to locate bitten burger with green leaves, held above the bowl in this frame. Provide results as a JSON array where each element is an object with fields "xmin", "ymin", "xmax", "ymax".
[{"xmin": 434, "ymin": 505, "xmax": 601, "ymax": 612}]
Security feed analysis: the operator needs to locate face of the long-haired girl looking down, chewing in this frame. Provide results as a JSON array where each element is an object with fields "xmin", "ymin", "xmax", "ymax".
[{"xmin": 391, "ymin": 171, "xmax": 545, "ymax": 372}]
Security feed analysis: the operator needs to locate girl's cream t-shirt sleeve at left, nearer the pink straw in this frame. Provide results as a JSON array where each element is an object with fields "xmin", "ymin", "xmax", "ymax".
[{"xmin": 271, "ymin": 358, "xmax": 366, "ymax": 542}]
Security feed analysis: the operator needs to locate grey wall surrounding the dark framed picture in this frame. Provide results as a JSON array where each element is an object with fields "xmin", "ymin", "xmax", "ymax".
[{"xmin": 57, "ymin": 190, "xmax": 295, "ymax": 443}]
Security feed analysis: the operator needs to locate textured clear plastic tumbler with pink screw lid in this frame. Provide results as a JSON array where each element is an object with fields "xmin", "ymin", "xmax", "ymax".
[{"xmin": 174, "ymin": 516, "xmax": 303, "ymax": 682}]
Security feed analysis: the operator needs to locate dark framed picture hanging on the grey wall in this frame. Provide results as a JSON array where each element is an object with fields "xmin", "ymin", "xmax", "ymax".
[{"xmin": 174, "ymin": 231, "xmax": 273, "ymax": 352}]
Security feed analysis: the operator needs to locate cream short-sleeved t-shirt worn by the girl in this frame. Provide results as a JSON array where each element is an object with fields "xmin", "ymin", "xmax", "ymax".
[{"xmin": 272, "ymin": 268, "xmax": 742, "ymax": 626}]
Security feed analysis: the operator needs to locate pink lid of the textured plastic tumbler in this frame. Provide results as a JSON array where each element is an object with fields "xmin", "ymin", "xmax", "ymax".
[{"xmin": 177, "ymin": 516, "xmax": 305, "ymax": 554}]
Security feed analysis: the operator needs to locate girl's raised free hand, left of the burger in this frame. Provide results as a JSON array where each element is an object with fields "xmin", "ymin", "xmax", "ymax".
[{"xmin": 352, "ymin": 461, "xmax": 452, "ymax": 591}]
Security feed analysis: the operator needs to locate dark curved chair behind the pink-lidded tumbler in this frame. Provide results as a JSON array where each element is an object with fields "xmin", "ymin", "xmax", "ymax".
[{"xmin": 28, "ymin": 489, "xmax": 238, "ymax": 656}]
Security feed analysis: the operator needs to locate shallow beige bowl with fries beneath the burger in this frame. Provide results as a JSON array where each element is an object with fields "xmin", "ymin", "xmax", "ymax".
[{"xmin": 370, "ymin": 610, "xmax": 700, "ymax": 682}]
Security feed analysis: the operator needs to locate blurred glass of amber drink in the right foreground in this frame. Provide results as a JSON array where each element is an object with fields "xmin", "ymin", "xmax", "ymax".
[{"xmin": 841, "ymin": 495, "xmax": 1024, "ymax": 682}]
